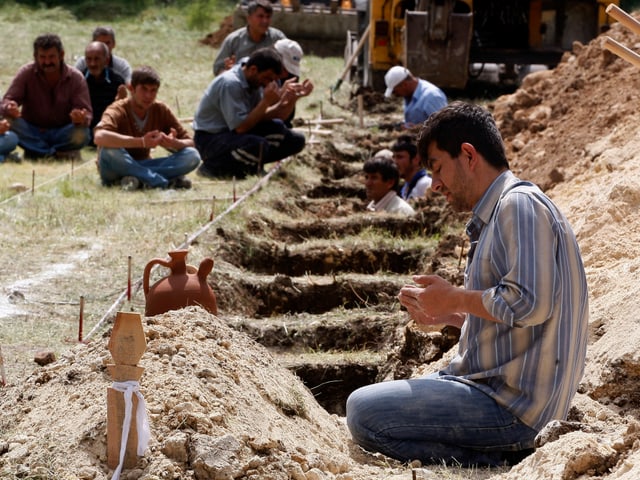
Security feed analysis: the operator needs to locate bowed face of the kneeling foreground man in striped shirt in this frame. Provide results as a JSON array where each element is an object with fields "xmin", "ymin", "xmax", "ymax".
[{"xmin": 427, "ymin": 142, "xmax": 475, "ymax": 212}]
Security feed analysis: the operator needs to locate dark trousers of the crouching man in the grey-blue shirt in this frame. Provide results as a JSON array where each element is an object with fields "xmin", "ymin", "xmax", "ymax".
[{"xmin": 194, "ymin": 120, "xmax": 305, "ymax": 178}]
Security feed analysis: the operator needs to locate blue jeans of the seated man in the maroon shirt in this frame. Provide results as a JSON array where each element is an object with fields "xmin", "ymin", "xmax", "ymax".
[{"xmin": 11, "ymin": 118, "xmax": 91, "ymax": 157}]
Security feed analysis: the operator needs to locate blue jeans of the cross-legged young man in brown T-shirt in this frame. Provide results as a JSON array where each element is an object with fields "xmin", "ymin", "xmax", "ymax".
[{"xmin": 99, "ymin": 147, "xmax": 200, "ymax": 188}]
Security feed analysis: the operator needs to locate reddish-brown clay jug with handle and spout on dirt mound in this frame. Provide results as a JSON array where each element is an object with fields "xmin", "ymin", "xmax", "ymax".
[{"xmin": 143, "ymin": 250, "xmax": 218, "ymax": 317}]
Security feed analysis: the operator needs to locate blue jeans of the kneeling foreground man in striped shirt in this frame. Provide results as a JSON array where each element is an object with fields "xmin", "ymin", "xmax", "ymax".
[{"xmin": 347, "ymin": 373, "xmax": 537, "ymax": 465}]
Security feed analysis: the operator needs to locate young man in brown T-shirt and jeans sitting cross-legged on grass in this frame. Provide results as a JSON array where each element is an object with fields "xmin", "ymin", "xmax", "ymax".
[{"xmin": 94, "ymin": 67, "xmax": 200, "ymax": 190}]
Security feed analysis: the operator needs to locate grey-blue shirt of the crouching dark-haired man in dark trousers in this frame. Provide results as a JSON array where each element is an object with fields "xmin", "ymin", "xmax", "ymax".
[{"xmin": 193, "ymin": 65, "xmax": 262, "ymax": 133}]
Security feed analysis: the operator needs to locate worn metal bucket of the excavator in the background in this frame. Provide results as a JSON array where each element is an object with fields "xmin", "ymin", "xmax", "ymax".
[{"xmin": 402, "ymin": 7, "xmax": 473, "ymax": 89}]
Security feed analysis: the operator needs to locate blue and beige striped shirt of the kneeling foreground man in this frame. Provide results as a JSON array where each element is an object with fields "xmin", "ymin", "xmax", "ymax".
[{"xmin": 445, "ymin": 171, "xmax": 589, "ymax": 430}]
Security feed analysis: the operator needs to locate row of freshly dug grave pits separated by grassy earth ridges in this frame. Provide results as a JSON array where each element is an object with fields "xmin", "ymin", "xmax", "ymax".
[{"xmin": 203, "ymin": 148, "xmax": 470, "ymax": 415}]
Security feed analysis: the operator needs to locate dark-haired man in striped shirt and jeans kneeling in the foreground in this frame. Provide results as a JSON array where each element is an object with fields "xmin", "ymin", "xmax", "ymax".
[{"xmin": 347, "ymin": 102, "xmax": 589, "ymax": 465}]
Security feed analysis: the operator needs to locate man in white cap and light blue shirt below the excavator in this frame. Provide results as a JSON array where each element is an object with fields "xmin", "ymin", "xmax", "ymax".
[{"xmin": 384, "ymin": 66, "xmax": 447, "ymax": 128}]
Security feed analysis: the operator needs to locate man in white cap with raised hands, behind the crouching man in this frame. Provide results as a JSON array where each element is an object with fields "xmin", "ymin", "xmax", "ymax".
[{"xmin": 274, "ymin": 38, "xmax": 313, "ymax": 128}]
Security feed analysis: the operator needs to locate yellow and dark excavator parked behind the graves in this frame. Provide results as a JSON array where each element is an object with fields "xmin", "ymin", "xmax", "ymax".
[{"xmin": 345, "ymin": 0, "xmax": 618, "ymax": 90}]
